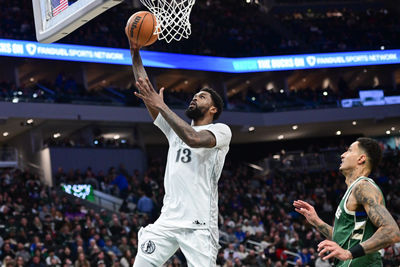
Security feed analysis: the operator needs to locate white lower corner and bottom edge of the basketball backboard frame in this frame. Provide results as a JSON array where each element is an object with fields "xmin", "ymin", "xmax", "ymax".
[{"xmin": 32, "ymin": 0, "xmax": 124, "ymax": 43}]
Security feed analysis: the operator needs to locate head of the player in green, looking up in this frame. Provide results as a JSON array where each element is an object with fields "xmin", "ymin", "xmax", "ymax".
[{"xmin": 339, "ymin": 137, "xmax": 382, "ymax": 173}]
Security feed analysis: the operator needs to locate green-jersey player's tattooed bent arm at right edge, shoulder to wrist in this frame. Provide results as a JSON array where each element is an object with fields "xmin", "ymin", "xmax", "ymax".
[{"xmin": 353, "ymin": 181, "xmax": 400, "ymax": 254}]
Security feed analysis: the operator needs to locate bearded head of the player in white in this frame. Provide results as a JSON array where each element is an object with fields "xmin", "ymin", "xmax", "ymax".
[{"xmin": 186, "ymin": 88, "xmax": 224, "ymax": 120}]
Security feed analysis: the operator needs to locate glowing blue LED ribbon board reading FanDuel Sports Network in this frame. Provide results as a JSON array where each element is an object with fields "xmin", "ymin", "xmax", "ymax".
[{"xmin": 0, "ymin": 39, "xmax": 400, "ymax": 73}]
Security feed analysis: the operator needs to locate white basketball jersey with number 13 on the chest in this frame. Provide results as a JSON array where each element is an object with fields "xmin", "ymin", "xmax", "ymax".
[{"xmin": 154, "ymin": 114, "xmax": 232, "ymax": 244}]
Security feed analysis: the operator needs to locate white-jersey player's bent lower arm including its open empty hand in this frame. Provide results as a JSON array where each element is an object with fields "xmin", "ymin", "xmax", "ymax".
[{"xmin": 135, "ymin": 78, "xmax": 217, "ymax": 148}]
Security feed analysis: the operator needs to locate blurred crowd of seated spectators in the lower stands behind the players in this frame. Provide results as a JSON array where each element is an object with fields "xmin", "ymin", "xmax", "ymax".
[{"xmin": 0, "ymin": 143, "xmax": 400, "ymax": 267}]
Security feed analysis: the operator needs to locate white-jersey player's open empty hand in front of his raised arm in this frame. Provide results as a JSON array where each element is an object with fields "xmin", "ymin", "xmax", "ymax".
[{"xmin": 134, "ymin": 78, "xmax": 165, "ymax": 109}]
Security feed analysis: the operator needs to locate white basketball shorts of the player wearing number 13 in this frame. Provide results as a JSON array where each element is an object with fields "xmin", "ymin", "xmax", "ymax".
[{"xmin": 138, "ymin": 224, "xmax": 218, "ymax": 267}]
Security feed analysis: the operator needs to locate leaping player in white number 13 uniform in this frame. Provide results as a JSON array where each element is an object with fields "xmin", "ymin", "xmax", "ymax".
[{"xmin": 131, "ymin": 49, "xmax": 232, "ymax": 267}]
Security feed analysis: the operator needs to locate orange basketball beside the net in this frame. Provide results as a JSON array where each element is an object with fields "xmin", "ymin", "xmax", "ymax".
[{"xmin": 125, "ymin": 11, "xmax": 158, "ymax": 48}]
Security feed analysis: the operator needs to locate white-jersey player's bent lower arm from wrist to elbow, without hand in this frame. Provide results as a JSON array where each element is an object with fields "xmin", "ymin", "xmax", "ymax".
[{"xmin": 159, "ymin": 104, "xmax": 217, "ymax": 148}]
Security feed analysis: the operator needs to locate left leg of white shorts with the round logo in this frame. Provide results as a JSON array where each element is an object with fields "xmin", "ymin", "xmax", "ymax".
[{"xmin": 134, "ymin": 224, "xmax": 178, "ymax": 267}]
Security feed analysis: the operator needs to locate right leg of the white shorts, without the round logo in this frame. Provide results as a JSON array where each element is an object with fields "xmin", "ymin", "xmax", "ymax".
[{"xmin": 177, "ymin": 229, "xmax": 218, "ymax": 267}]
